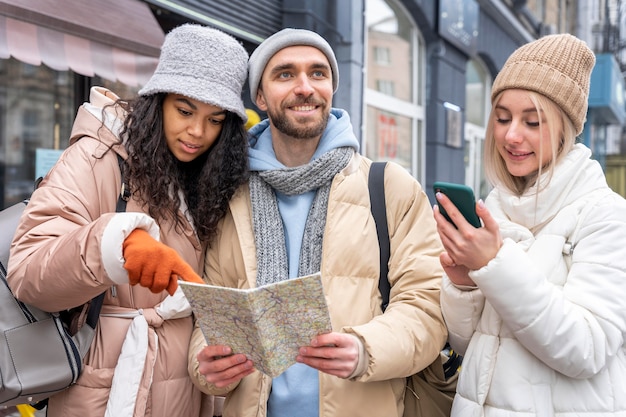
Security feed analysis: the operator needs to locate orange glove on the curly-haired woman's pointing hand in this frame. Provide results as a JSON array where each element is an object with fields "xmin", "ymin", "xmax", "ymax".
[{"xmin": 123, "ymin": 229, "xmax": 204, "ymax": 295}]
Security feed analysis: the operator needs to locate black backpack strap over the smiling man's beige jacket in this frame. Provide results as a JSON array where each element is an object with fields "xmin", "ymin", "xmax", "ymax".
[{"xmin": 368, "ymin": 162, "xmax": 391, "ymax": 311}]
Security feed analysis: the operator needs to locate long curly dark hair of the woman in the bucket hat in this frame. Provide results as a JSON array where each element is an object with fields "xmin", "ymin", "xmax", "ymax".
[{"xmin": 120, "ymin": 93, "xmax": 249, "ymax": 245}]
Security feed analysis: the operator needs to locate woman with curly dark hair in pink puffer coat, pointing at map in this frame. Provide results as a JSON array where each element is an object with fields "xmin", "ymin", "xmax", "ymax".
[{"xmin": 8, "ymin": 24, "xmax": 248, "ymax": 417}]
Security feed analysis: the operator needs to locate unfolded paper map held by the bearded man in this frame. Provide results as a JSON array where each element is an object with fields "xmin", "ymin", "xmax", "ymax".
[{"xmin": 178, "ymin": 273, "xmax": 331, "ymax": 377}]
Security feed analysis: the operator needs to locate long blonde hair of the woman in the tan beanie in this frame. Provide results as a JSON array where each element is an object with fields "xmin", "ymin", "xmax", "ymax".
[{"xmin": 484, "ymin": 90, "xmax": 576, "ymax": 196}]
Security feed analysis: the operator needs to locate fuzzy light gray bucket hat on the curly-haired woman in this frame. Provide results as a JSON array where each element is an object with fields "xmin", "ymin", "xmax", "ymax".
[{"xmin": 139, "ymin": 24, "xmax": 248, "ymax": 123}]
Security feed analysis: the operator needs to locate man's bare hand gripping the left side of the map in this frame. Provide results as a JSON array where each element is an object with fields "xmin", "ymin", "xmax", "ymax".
[{"xmin": 197, "ymin": 345, "xmax": 254, "ymax": 388}]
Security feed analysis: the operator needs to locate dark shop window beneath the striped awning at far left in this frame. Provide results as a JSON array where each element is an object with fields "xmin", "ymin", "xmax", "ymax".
[{"xmin": 0, "ymin": 58, "xmax": 138, "ymax": 208}]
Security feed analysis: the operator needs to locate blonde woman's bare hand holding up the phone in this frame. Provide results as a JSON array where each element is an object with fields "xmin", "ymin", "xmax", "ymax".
[{"xmin": 434, "ymin": 193, "xmax": 502, "ymax": 276}]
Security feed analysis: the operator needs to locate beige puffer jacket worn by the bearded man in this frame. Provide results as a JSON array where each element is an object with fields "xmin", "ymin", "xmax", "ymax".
[{"xmin": 190, "ymin": 155, "xmax": 447, "ymax": 417}]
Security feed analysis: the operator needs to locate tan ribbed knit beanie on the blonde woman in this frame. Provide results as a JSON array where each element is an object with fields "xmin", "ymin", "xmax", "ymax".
[{"xmin": 491, "ymin": 34, "xmax": 596, "ymax": 135}]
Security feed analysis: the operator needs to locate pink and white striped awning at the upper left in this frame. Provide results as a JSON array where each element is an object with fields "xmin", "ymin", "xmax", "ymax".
[{"xmin": 0, "ymin": 0, "xmax": 165, "ymax": 86}]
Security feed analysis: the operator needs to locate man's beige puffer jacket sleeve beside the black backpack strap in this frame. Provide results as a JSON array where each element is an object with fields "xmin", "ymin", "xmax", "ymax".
[{"xmin": 343, "ymin": 163, "xmax": 447, "ymax": 381}]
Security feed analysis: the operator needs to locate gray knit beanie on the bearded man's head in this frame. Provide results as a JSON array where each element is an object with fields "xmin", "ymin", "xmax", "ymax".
[{"xmin": 248, "ymin": 28, "xmax": 339, "ymax": 103}]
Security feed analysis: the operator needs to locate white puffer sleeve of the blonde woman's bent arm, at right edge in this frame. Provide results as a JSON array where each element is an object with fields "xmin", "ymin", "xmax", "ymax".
[{"xmin": 471, "ymin": 196, "xmax": 626, "ymax": 378}]
